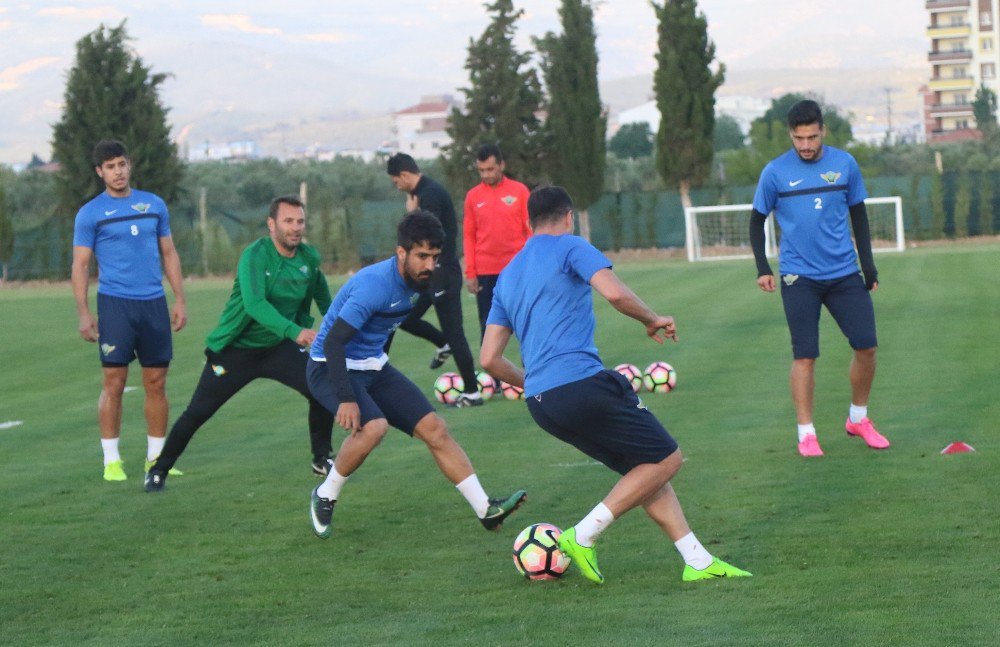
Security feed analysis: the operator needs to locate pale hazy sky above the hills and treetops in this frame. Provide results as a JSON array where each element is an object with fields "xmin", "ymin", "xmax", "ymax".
[{"xmin": 0, "ymin": 0, "xmax": 928, "ymax": 162}]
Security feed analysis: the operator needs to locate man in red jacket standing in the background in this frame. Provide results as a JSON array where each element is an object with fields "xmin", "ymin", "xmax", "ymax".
[{"xmin": 463, "ymin": 144, "xmax": 531, "ymax": 339}]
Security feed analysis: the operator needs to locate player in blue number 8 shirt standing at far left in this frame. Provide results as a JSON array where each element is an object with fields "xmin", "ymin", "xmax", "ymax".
[{"xmin": 72, "ymin": 141, "xmax": 187, "ymax": 481}]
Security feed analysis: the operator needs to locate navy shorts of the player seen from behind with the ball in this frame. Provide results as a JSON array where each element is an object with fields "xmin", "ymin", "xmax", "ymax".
[{"xmin": 527, "ymin": 370, "xmax": 677, "ymax": 474}]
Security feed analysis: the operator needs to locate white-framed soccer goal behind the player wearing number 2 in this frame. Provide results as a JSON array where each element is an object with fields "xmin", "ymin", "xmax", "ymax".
[{"xmin": 684, "ymin": 197, "xmax": 906, "ymax": 261}]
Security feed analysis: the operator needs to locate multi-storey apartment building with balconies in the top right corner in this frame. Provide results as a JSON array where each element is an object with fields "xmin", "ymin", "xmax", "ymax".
[{"xmin": 924, "ymin": 0, "xmax": 1000, "ymax": 142}]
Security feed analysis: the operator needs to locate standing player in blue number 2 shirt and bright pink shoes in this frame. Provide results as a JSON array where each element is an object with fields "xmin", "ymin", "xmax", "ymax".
[{"xmin": 750, "ymin": 100, "xmax": 889, "ymax": 456}]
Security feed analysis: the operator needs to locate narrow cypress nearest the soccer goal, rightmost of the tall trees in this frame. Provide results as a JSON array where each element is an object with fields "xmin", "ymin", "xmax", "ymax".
[{"xmin": 650, "ymin": 0, "xmax": 726, "ymax": 207}]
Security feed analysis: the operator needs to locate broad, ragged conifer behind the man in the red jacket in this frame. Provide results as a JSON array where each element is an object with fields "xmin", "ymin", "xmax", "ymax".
[{"xmin": 443, "ymin": 0, "xmax": 542, "ymax": 191}]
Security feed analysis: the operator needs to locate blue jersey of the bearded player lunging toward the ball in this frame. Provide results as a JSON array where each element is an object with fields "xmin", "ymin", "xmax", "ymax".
[{"xmin": 309, "ymin": 256, "xmax": 419, "ymax": 369}]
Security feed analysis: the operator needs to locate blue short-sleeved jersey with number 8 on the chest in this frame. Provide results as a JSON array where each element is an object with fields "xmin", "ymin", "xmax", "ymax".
[{"xmin": 73, "ymin": 189, "xmax": 170, "ymax": 300}]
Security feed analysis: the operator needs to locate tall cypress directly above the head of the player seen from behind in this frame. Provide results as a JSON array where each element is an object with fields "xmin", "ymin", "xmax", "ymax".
[{"xmin": 536, "ymin": 0, "xmax": 607, "ymax": 239}]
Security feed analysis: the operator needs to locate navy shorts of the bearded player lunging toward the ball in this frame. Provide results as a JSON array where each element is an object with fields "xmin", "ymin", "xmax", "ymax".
[{"xmin": 306, "ymin": 358, "xmax": 434, "ymax": 436}]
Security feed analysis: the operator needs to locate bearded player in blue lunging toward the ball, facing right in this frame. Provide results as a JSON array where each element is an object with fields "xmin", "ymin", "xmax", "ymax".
[{"xmin": 306, "ymin": 211, "xmax": 526, "ymax": 539}]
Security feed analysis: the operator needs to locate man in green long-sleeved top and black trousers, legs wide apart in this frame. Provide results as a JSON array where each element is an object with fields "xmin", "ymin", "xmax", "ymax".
[{"xmin": 145, "ymin": 196, "xmax": 333, "ymax": 492}]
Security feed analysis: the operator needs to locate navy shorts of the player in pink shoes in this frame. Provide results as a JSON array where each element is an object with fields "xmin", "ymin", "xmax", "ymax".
[{"xmin": 781, "ymin": 274, "xmax": 878, "ymax": 359}]
